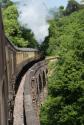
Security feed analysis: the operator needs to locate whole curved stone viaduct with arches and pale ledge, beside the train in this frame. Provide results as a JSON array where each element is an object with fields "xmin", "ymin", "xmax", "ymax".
[{"xmin": 13, "ymin": 61, "xmax": 47, "ymax": 125}]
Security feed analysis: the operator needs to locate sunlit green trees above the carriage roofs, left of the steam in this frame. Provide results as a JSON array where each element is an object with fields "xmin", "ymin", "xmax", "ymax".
[{"xmin": 3, "ymin": 1, "xmax": 38, "ymax": 48}]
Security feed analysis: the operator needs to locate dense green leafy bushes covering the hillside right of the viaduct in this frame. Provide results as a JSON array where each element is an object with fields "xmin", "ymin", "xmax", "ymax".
[{"xmin": 41, "ymin": 1, "xmax": 84, "ymax": 125}]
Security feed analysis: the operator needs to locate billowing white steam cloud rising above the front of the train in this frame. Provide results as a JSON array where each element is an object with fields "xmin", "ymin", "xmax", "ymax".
[{"xmin": 12, "ymin": 0, "xmax": 49, "ymax": 44}]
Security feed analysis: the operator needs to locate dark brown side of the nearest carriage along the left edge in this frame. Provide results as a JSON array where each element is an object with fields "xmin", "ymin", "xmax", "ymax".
[{"xmin": 0, "ymin": 7, "xmax": 8, "ymax": 125}]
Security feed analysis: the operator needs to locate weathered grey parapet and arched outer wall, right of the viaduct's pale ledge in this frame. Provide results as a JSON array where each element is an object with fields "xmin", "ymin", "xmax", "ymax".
[{"xmin": 24, "ymin": 61, "xmax": 47, "ymax": 125}]
